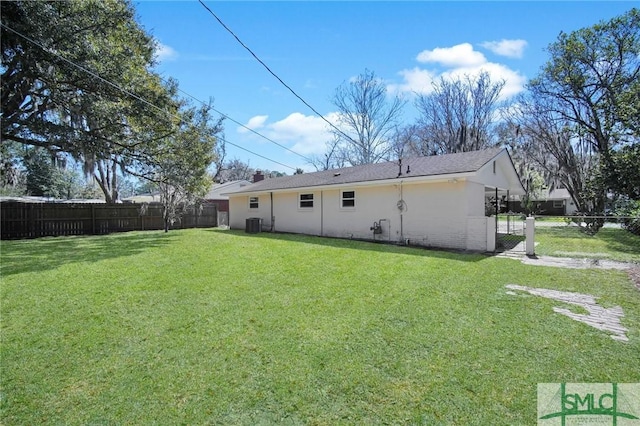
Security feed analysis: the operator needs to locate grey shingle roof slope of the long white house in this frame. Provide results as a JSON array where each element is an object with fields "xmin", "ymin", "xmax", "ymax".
[{"xmin": 233, "ymin": 148, "xmax": 503, "ymax": 193}]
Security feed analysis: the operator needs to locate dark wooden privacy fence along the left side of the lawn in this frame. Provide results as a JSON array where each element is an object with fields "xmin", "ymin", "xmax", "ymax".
[{"xmin": 0, "ymin": 202, "xmax": 218, "ymax": 240}]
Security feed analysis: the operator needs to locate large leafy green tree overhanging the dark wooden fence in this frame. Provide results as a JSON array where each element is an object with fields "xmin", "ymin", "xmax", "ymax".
[{"xmin": 0, "ymin": 0, "xmax": 177, "ymax": 202}]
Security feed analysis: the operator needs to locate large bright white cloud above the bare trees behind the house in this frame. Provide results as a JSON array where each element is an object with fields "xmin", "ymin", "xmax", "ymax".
[{"xmin": 387, "ymin": 43, "xmax": 526, "ymax": 99}]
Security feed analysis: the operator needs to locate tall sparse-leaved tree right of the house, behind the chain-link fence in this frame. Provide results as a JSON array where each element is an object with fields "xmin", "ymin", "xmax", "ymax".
[{"xmin": 511, "ymin": 9, "xmax": 640, "ymax": 231}]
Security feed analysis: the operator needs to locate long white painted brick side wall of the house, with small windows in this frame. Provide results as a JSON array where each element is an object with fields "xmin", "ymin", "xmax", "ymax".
[{"xmin": 230, "ymin": 180, "xmax": 488, "ymax": 251}]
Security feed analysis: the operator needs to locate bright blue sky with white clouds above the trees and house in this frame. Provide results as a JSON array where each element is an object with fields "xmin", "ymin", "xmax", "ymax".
[{"xmin": 134, "ymin": 1, "xmax": 640, "ymax": 174}]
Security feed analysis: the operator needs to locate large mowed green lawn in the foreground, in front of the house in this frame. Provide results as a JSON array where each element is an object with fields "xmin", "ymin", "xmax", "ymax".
[{"xmin": 0, "ymin": 230, "xmax": 640, "ymax": 425}]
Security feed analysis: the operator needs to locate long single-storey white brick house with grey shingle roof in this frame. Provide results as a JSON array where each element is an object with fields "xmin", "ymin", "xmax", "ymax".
[{"xmin": 227, "ymin": 148, "xmax": 524, "ymax": 251}]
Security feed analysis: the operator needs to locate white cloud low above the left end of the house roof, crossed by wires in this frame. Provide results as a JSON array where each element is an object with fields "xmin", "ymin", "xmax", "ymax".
[{"xmin": 238, "ymin": 112, "xmax": 338, "ymax": 156}]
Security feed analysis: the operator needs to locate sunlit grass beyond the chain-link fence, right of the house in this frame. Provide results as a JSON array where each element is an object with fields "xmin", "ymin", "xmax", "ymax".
[{"xmin": 535, "ymin": 223, "xmax": 640, "ymax": 263}]
